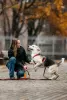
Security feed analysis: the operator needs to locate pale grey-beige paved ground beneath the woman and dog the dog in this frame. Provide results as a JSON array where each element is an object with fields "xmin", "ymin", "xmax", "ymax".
[{"xmin": 0, "ymin": 63, "xmax": 67, "ymax": 100}]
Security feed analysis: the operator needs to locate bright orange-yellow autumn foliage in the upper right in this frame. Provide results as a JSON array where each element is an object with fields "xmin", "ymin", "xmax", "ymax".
[{"xmin": 28, "ymin": 0, "xmax": 67, "ymax": 36}]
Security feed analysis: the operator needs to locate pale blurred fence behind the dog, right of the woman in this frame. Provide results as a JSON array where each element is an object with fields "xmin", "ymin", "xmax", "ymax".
[{"xmin": 29, "ymin": 36, "xmax": 67, "ymax": 58}]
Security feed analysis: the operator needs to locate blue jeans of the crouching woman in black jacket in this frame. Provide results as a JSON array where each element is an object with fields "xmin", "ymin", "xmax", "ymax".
[{"xmin": 6, "ymin": 57, "xmax": 24, "ymax": 78}]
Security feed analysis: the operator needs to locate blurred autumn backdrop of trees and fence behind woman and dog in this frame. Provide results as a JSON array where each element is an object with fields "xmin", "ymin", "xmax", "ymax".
[{"xmin": 0, "ymin": 0, "xmax": 67, "ymax": 63}]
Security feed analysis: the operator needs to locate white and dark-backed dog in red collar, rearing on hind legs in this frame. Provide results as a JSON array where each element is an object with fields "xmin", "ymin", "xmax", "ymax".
[{"xmin": 28, "ymin": 45, "xmax": 62, "ymax": 79}]
